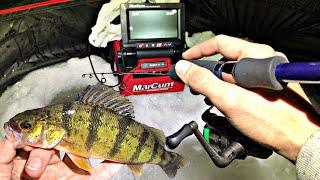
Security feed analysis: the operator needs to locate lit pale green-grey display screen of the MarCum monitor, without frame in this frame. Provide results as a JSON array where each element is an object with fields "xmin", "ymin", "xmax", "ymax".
[{"xmin": 128, "ymin": 9, "xmax": 179, "ymax": 40}]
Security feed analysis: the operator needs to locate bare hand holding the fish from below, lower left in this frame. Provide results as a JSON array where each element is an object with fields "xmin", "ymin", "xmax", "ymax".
[{"xmin": 0, "ymin": 132, "xmax": 123, "ymax": 180}]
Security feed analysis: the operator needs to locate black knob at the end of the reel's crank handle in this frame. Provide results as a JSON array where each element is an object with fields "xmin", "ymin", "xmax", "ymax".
[{"xmin": 166, "ymin": 124, "xmax": 193, "ymax": 149}]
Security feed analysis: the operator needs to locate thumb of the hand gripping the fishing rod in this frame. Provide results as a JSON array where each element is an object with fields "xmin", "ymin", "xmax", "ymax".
[{"xmin": 175, "ymin": 60, "xmax": 250, "ymax": 113}]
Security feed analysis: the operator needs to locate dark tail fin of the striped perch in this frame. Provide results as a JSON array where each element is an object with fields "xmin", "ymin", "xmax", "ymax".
[{"xmin": 160, "ymin": 152, "xmax": 189, "ymax": 178}]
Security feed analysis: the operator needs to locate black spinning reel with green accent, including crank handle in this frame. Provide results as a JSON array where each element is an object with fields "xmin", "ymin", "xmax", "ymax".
[{"xmin": 166, "ymin": 99, "xmax": 273, "ymax": 168}]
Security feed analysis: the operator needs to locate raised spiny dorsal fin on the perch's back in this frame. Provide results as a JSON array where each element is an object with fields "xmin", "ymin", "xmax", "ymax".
[{"xmin": 79, "ymin": 84, "xmax": 134, "ymax": 118}]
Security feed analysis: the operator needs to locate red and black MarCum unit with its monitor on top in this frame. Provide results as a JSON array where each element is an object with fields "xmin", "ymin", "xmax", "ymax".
[{"xmin": 112, "ymin": 3, "xmax": 185, "ymax": 96}]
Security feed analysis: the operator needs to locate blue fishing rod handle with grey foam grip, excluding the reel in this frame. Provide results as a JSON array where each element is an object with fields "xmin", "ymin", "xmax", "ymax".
[{"xmin": 168, "ymin": 56, "xmax": 320, "ymax": 90}]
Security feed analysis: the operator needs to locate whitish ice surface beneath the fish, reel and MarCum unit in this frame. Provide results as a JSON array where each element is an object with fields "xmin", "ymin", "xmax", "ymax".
[{"xmin": 0, "ymin": 57, "xmax": 295, "ymax": 180}]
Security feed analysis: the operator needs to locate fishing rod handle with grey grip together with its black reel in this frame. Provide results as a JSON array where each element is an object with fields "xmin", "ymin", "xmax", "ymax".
[{"xmin": 166, "ymin": 56, "xmax": 320, "ymax": 168}]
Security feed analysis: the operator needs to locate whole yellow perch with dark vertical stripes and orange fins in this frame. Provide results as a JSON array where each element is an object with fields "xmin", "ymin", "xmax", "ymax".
[{"xmin": 4, "ymin": 85, "xmax": 187, "ymax": 177}]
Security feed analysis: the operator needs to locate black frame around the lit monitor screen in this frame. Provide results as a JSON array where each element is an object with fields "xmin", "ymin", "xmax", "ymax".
[{"xmin": 120, "ymin": 3, "xmax": 185, "ymax": 47}]
